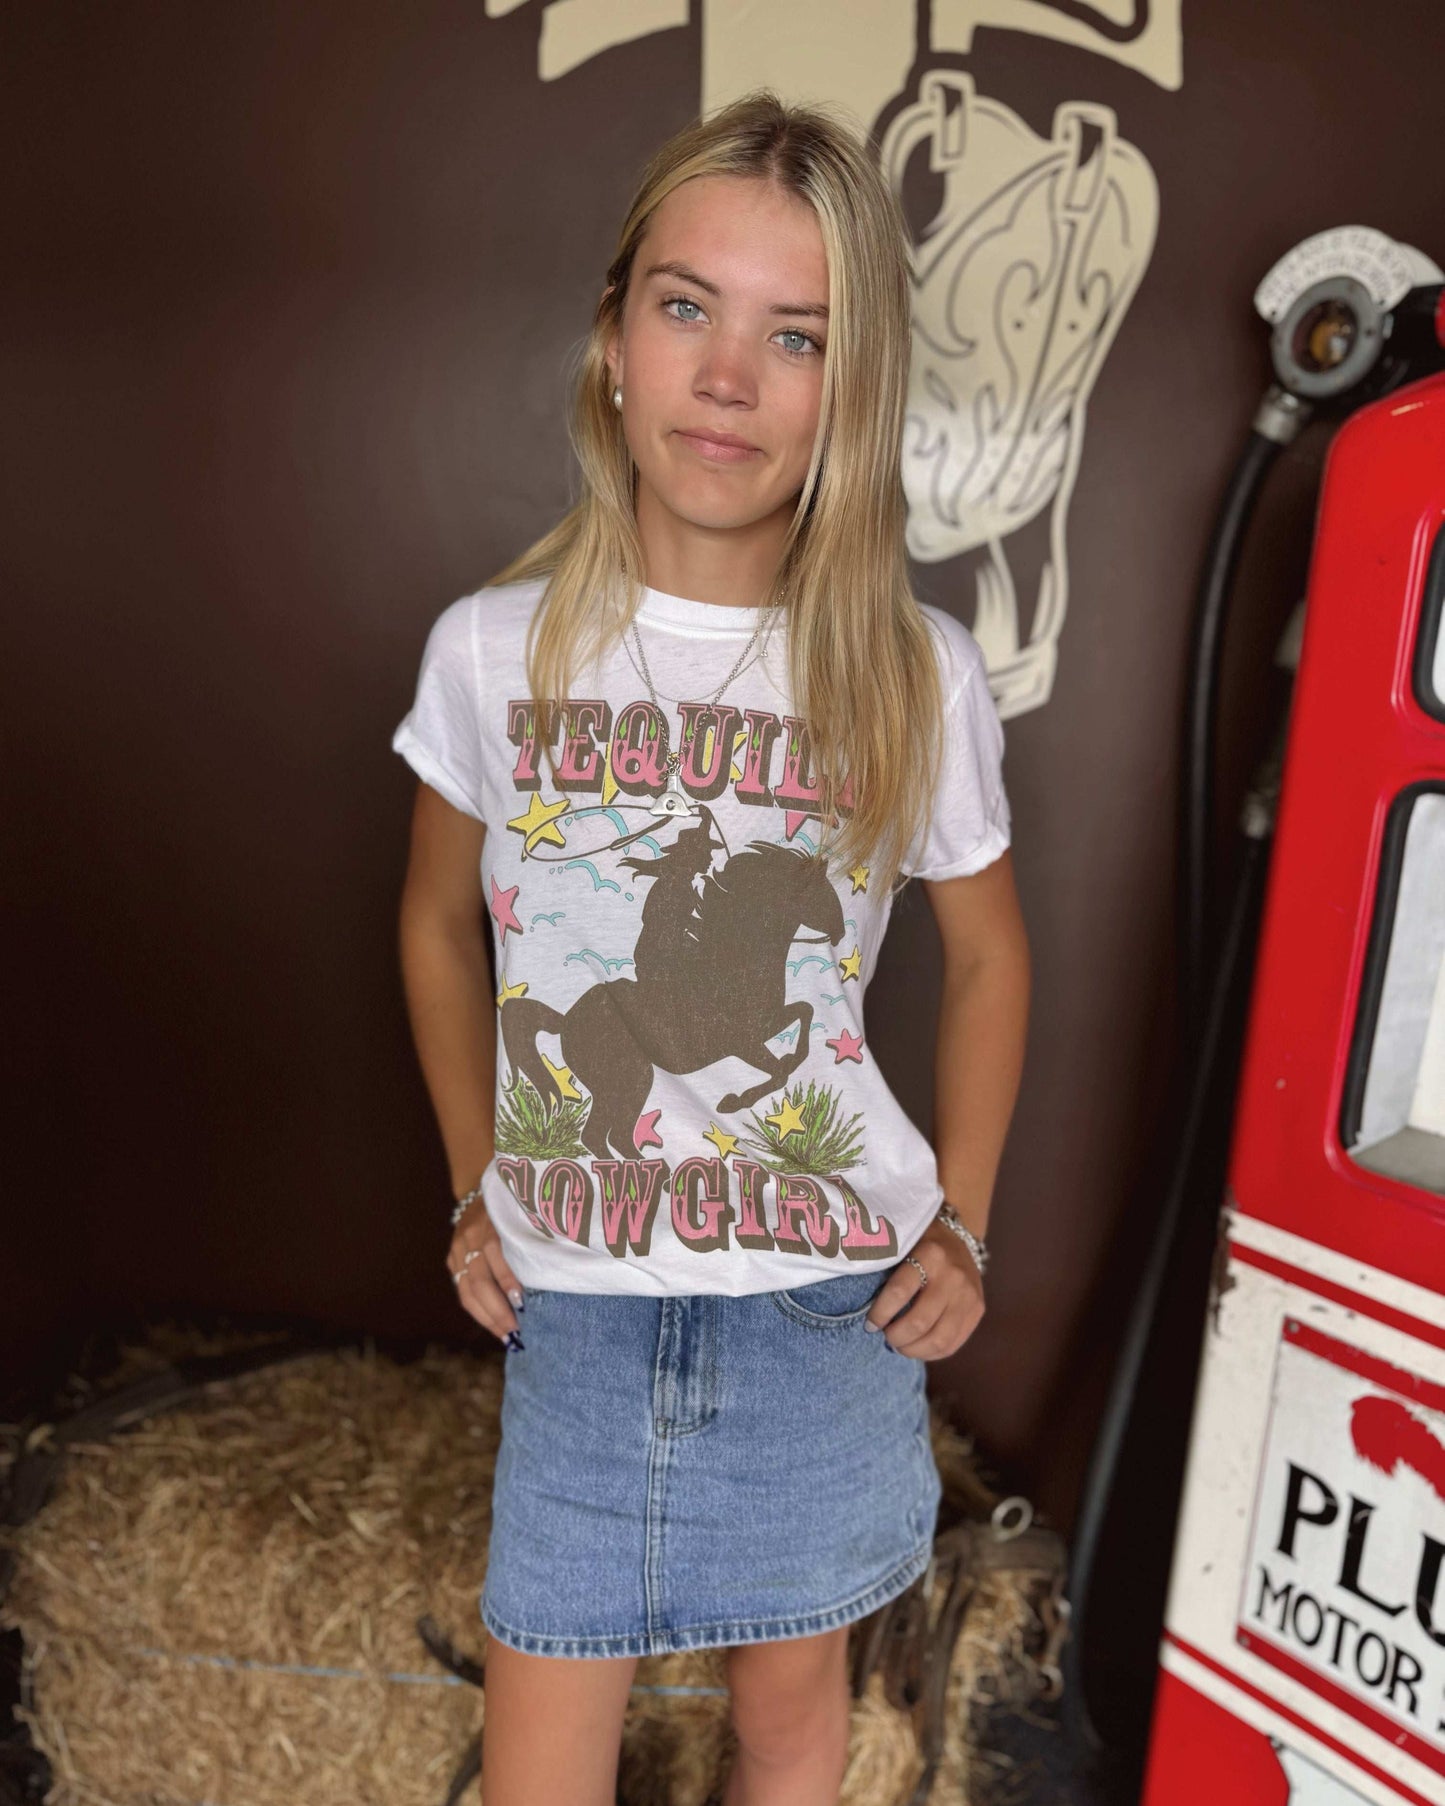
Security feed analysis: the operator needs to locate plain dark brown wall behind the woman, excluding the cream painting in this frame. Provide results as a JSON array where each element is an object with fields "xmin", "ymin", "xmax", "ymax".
[{"xmin": 0, "ymin": 0, "xmax": 1445, "ymax": 1560}]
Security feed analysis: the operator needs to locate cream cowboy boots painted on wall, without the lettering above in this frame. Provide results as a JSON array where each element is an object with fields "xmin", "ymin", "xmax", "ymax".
[{"xmin": 881, "ymin": 69, "xmax": 1158, "ymax": 717}]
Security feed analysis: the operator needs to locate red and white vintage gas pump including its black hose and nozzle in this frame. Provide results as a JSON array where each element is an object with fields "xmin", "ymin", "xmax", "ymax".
[{"xmin": 1053, "ymin": 226, "xmax": 1445, "ymax": 1806}]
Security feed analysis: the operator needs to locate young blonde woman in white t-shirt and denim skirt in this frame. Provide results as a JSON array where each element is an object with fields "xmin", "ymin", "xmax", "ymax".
[{"xmin": 394, "ymin": 90, "xmax": 1030, "ymax": 1806}]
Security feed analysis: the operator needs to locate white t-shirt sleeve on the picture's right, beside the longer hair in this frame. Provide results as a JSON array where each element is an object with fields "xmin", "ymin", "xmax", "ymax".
[{"xmin": 903, "ymin": 609, "xmax": 1012, "ymax": 880}]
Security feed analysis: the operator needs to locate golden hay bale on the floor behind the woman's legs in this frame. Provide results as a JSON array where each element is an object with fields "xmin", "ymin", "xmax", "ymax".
[{"xmin": 0, "ymin": 1326, "xmax": 1062, "ymax": 1806}]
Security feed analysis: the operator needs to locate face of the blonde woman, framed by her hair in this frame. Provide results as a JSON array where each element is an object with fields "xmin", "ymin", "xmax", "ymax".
[{"xmin": 607, "ymin": 175, "xmax": 827, "ymax": 549}]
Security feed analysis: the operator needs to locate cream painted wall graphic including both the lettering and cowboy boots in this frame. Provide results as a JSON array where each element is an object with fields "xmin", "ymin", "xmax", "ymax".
[{"xmin": 486, "ymin": 0, "xmax": 1183, "ymax": 719}]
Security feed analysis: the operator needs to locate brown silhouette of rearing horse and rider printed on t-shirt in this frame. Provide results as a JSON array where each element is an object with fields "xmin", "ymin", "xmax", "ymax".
[{"xmin": 499, "ymin": 822, "xmax": 844, "ymax": 1159}]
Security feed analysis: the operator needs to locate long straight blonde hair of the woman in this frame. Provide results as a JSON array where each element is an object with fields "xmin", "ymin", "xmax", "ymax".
[{"xmin": 489, "ymin": 88, "xmax": 945, "ymax": 889}]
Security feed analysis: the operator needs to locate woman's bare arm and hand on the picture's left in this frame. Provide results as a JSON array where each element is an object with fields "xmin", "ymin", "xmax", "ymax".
[{"xmin": 397, "ymin": 784, "xmax": 522, "ymax": 1336}]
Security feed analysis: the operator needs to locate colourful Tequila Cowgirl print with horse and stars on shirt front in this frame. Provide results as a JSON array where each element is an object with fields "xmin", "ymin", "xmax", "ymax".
[{"xmin": 489, "ymin": 699, "xmax": 898, "ymax": 1262}]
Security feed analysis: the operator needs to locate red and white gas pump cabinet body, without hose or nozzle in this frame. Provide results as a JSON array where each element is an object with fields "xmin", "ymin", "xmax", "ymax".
[{"xmin": 1143, "ymin": 355, "xmax": 1445, "ymax": 1806}]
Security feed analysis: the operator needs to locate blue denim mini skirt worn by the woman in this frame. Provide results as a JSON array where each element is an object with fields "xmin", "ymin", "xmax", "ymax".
[{"xmin": 479, "ymin": 1268, "xmax": 943, "ymax": 1656}]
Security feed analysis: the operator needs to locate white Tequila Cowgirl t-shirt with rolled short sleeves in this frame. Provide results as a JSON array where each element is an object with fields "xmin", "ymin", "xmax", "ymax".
[{"xmin": 392, "ymin": 578, "xmax": 1010, "ymax": 1295}]
